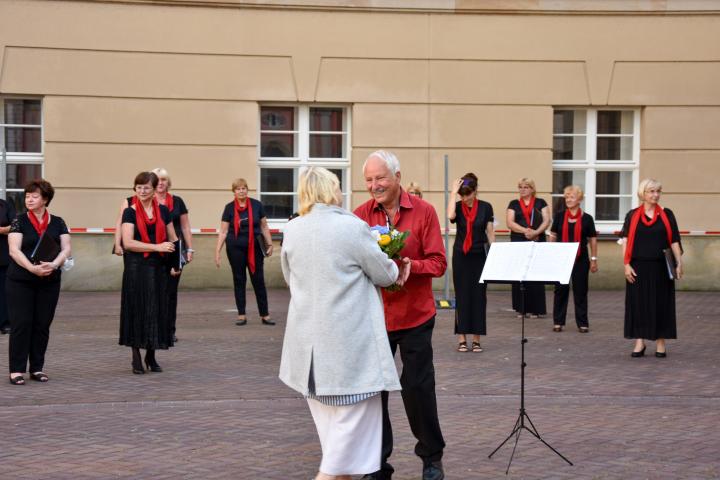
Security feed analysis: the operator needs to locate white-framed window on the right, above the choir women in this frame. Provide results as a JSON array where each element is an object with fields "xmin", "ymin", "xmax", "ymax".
[{"xmin": 552, "ymin": 107, "xmax": 640, "ymax": 232}]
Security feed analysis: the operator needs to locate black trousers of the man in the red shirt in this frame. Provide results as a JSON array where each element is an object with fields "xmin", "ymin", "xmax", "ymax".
[{"xmin": 381, "ymin": 317, "xmax": 445, "ymax": 478}]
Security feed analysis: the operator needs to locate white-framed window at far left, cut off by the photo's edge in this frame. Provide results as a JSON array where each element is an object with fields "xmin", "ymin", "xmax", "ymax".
[{"xmin": 0, "ymin": 96, "xmax": 44, "ymax": 212}]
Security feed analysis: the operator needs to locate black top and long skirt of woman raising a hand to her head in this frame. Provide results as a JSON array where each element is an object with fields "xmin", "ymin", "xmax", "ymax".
[{"xmin": 451, "ymin": 200, "xmax": 494, "ymax": 335}]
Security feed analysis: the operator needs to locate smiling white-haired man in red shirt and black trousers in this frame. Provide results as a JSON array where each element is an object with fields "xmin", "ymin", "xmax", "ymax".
[{"xmin": 355, "ymin": 150, "xmax": 447, "ymax": 480}]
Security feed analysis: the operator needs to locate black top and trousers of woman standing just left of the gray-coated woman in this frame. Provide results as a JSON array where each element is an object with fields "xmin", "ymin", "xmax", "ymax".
[{"xmin": 222, "ymin": 198, "xmax": 269, "ymax": 317}]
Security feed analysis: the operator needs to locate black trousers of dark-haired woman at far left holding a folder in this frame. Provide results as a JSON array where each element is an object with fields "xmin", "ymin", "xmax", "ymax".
[{"xmin": 5, "ymin": 278, "xmax": 60, "ymax": 373}]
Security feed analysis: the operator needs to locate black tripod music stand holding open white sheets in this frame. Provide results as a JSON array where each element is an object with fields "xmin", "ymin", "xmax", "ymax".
[{"xmin": 480, "ymin": 242, "xmax": 578, "ymax": 475}]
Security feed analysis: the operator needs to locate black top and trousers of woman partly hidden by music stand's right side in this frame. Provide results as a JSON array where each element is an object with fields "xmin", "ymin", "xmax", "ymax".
[{"xmin": 550, "ymin": 210, "xmax": 597, "ymax": 327}]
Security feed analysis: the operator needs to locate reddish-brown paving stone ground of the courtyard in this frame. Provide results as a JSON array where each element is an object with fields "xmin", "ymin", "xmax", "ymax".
[{"xmin": 0, "ymin": 290, "xmax": 720, "ymax": 480}]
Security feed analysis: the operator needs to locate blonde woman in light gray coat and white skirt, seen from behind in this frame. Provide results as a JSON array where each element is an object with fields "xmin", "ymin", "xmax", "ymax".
[{"xmin": 280, "ymin": 167, "xmax": 409, "ymax": 480}]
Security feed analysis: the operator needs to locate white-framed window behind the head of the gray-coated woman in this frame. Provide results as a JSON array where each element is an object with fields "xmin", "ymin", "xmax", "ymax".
[{"xmin": 258, "ymin": 104, "xmax": 351, "ymax": 225}]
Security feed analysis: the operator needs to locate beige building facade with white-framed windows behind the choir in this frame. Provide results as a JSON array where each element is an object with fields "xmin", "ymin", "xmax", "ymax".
[{"xmin": 0, "ymin": 0, "xmax": 720, "ymax": 289}]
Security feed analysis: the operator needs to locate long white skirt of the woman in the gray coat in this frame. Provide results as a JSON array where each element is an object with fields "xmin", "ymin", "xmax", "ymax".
[{"xmin": 308, "ymin": 395, "xmax": 382, "ymax": 475}]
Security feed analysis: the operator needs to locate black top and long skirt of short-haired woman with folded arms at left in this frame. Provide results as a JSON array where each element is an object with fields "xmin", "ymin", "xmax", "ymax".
[{"xmin": 119, "ymin": 205, "xmax": 173, "ymax": 350}]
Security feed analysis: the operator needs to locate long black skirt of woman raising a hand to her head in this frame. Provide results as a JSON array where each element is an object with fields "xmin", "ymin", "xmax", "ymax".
[{"xmin": 452, "ymin": 249, "xmax": 487, "ymax": 335}]
